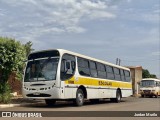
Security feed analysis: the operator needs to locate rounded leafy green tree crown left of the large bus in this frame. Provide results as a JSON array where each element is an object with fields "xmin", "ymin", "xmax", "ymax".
[{"xmin": 0, "ymin": 37, "xmax": 26, "ymax": 82}]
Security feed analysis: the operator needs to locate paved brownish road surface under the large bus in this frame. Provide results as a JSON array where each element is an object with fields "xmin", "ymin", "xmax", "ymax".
[{"xmin": 0, "ymin": 97, "xmax": 160, "ymax": 120}]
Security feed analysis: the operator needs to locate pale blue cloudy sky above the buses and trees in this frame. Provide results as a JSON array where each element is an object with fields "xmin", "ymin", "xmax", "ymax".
[{"xmin": 0, "ymin": 0, "xmax": 160, "ymax": 78}]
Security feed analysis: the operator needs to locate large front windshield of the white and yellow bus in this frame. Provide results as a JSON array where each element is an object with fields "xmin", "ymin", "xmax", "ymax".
[{"xmin": 24, "ymin": 58, "xmax": 59, "ymax": 82}]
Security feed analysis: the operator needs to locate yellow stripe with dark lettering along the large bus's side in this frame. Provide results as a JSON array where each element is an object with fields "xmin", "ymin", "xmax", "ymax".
[{"xmin": 65, "ymin": 77, "xmax": 132, "ymax": 88}]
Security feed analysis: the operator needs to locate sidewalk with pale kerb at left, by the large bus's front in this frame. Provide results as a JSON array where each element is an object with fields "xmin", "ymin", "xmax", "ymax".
[{"xmin": 0, "ymin": 96, "xmax": 39, "ymax": 108}]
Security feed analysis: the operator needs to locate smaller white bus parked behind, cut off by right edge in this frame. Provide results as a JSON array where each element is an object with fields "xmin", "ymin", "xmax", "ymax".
[{"xmin": 140, "ymin": 78, "xmax": 160, "ymax": 98}]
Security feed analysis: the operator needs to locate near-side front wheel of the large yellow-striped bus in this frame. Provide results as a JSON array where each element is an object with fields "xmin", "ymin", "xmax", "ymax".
[{"xmin": 75, "ymin": 89, "xmax": 84, "ymax": 106}]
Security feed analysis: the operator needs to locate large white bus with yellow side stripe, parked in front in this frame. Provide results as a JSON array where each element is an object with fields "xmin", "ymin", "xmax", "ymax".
[{"xmin": 22, "ymin": 49, "xmax": 132, "ymax": 106}]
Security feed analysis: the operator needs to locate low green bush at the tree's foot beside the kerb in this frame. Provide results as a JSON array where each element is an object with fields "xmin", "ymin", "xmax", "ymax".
[{"xmin": 0, "ymin": 82, "xmax": 12, "ymax": 104}]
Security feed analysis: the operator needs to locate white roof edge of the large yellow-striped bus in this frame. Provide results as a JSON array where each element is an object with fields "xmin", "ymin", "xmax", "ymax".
[{"xmin": 31, "ymin": 49, "xmax": 130, "ymax": 70}]
